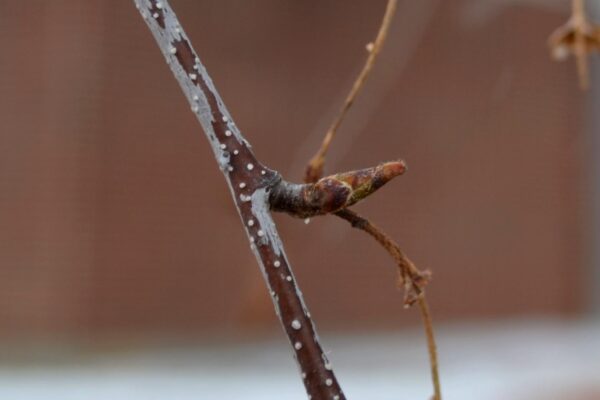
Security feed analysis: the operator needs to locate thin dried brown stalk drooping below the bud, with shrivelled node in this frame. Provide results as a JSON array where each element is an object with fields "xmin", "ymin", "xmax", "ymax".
[{"xmin": 335, "ymin": 209, "xmax": 442, "ymax": 400}]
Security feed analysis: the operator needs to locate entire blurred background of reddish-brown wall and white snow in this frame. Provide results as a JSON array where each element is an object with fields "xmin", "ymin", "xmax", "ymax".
[{"xmin": 0, "ymin": 0, "xmax": 600, "ymax": 400}]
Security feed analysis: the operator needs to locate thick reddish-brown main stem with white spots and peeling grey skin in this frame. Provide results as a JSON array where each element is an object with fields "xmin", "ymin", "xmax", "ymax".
[{"xmin": 134, "ymin": 0, "xmax": 345, "ymax": 400}]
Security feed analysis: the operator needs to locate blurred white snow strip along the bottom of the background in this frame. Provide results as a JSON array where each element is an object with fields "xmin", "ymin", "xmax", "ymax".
[{"xmin": 0, "ymin": 320, "xmax": 600, "ymax": 400}]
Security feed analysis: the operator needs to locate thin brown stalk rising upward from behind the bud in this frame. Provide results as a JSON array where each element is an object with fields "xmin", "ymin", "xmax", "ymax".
[{"xmin": 304, "ymin": 0, "xmax": 397, "ymax": 182}]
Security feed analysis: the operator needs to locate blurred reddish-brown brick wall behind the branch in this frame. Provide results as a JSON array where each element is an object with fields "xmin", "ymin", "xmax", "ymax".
[{"xmin": 0, "ymin": 0, "xmax": 584, "ymax": 337}]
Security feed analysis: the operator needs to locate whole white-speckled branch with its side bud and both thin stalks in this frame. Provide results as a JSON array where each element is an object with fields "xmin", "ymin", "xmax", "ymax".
[{"xmin": 134, "ymin": 0, "xmax": 440, "ymax": 400}]
